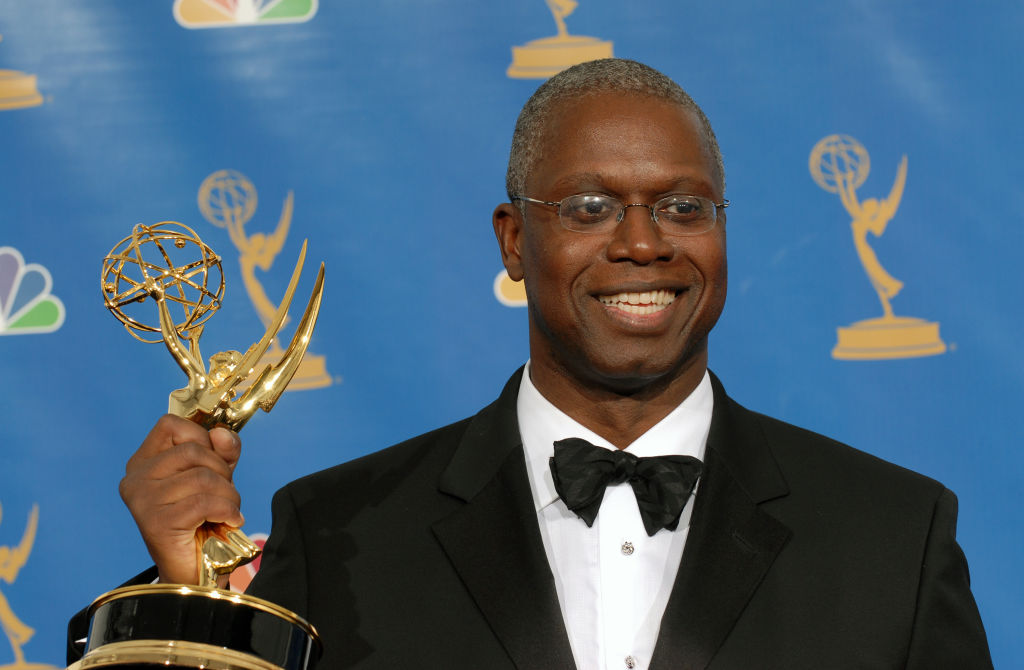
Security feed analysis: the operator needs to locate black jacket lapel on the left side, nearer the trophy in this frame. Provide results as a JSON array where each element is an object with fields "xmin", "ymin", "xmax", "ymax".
[{"xmin": 433, "ymin": 370, "xmax": 574, "ymax": 668}]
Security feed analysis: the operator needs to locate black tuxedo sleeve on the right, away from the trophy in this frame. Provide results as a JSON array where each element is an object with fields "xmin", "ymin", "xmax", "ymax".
[{"xmin": 906, "ymin": 490, "xmax": 992, "ymax": 670}]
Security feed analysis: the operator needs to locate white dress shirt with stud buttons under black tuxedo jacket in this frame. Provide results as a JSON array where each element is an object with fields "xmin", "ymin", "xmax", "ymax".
[{"xmin": 517, "ymin": 364, "xmax": 714, "ymax": 670}]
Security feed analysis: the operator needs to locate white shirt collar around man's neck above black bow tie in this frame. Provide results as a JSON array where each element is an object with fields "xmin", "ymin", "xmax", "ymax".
[{"xmin": 516, "ymin": 362, "xmax": 715, "ymax": 511}]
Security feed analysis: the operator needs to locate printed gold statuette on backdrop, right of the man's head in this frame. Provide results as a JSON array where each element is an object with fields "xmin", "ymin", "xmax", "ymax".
[{"xmin": 809, "ymin": 135, "xmax": 946, "ymax": 361}]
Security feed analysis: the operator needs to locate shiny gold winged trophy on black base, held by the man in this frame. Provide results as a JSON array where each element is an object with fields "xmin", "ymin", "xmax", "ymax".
[{"xmin": 86, "ymin": 221, "xmax": 324, "ymax": 670}]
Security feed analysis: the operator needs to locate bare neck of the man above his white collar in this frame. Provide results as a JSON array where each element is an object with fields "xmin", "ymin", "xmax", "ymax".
[{"xmin": 530, "ymin": 349, "xmax": 708, "ymax": 449}]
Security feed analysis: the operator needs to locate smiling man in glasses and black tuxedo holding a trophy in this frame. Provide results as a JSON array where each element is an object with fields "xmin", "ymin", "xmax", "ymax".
[{"xmin": 66, "ymin": 59, "xmax": 991, "ymax": 670}]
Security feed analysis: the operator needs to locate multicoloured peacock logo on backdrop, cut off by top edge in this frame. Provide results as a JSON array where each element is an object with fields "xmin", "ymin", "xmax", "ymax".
[{"xmin": 174, "ymin": 0, "xmax": 318, "ymax": 28}]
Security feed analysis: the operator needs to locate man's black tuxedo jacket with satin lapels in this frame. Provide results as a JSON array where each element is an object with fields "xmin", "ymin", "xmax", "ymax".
[{"xmin": 66, "ymin": 371, "xmax": 991, "ymax": 670}]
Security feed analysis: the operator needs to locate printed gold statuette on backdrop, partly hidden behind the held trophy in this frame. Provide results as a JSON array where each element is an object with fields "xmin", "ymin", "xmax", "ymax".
[{"xmin": 199, "ymin": 170, "xmax": 333, "ymax": 390}]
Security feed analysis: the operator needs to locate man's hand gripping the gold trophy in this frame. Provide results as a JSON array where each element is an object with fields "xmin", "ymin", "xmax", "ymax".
[{"xmin": 120, "ymin": 414, "xmax": 245, "ymax": 584}]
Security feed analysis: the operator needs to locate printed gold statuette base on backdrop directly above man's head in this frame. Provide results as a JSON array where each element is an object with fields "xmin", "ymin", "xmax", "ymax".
[{"xmin": 507, "ymin": 0, "xmax": 612, "ymax": 79}]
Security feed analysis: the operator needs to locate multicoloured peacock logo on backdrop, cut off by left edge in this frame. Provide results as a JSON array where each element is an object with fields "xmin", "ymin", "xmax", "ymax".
[{"xmin": 0, "ymin": 247, "xmax": 65, "ymax": 335}]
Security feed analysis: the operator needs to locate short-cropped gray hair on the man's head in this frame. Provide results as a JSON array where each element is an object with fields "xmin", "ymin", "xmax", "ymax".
[{"xmin": 505, "ymin": 58, "xmax": 725, "ymax": 199}]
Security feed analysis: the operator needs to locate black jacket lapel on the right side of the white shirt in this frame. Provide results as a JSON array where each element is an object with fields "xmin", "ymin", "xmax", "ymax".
[{"xmin": 651, "ymin": 375, "xmax": 790, "ymax": 670}]
